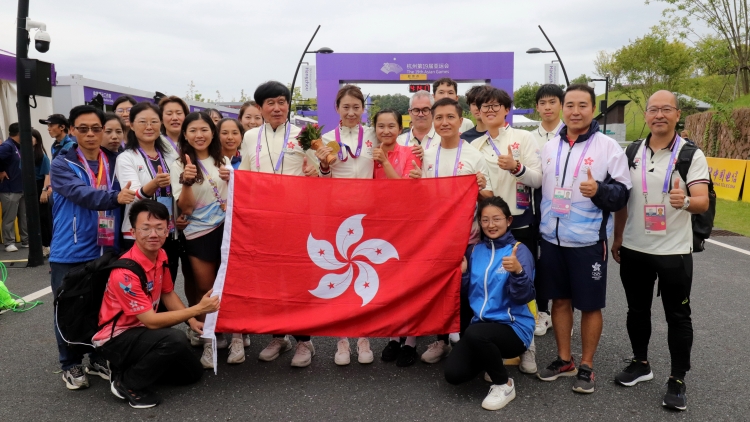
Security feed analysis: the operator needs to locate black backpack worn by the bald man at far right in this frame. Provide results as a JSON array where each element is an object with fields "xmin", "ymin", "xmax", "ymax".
[{"xmin": 625, "ymin": 138, "xmax": 716, "ymax": 252}]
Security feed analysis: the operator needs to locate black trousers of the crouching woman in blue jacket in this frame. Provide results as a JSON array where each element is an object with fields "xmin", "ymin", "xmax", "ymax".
[{"xmin": 445, "ymin": 322, "xmax": 526, "ymax": 384}]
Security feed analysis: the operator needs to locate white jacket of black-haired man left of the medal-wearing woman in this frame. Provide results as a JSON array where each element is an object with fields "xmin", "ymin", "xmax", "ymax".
[{"xmin": 239, "ymin": 122, "xmax": 318, "ymax": 176}]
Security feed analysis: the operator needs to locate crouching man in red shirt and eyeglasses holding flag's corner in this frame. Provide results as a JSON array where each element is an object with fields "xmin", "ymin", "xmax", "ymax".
[{"xmin": 93, "ymin": 199, "xmax": 219, "ymax": 409}]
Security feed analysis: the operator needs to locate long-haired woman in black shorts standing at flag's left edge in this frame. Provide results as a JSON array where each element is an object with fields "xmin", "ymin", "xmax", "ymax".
[{"xmin": 170, "ymin": 112, "xmax": 245, "ymax": 369}]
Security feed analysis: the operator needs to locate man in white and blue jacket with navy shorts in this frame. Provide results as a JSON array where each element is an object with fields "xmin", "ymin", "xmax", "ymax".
[{"xmin": 538, "ymin": 84, "xmax": 632, "ymax": 393}]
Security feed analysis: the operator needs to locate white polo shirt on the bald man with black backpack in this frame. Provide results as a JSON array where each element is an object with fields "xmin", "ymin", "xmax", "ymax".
[{"xmin": 622, "ymin": 135, "xmax": 708, "ymax": 255}]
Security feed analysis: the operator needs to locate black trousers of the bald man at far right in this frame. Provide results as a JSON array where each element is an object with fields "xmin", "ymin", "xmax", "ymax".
[{"xmin": 620, "ymin": 248, "xmax": 693, "ymax": 379}]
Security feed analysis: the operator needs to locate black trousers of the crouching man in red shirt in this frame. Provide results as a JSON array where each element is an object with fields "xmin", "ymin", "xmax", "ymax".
[{"xmin": 100, "ymin": 327, "xmax": 203, "ymax": 390}]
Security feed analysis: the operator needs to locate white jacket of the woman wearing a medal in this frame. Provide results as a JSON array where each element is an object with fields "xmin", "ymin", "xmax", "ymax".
[{"xmin": 321, "ymin": 126, "xmax": 380, "ymax": 179}]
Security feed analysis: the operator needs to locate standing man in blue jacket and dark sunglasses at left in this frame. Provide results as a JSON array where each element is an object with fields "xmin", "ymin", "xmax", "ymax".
[{"xmin": 49, "ymin": 105, "xmax": 135, "ymax": 390}]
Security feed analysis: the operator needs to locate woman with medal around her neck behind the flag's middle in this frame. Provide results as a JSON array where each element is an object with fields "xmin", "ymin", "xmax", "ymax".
[{"xmin": 315, "ymin": 85, "xmax": 378, "ymax": 366}]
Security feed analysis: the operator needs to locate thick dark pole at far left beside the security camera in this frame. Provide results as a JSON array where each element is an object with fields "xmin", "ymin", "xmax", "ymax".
[{"xmin": 14, "ymin": 0, "xmax": 44, "ymax": 267}]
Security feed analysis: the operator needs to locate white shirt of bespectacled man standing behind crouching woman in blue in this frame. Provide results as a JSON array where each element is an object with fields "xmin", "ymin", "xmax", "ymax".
[{"xmin": 472, "ymin": 125, "xmax": 542, "ymax": 215}]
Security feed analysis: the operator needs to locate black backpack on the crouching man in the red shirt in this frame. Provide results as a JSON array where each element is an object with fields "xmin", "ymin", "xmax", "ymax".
[{"xmin": 54, "ymin": 251, "xmax": 150, "ymax": 347}]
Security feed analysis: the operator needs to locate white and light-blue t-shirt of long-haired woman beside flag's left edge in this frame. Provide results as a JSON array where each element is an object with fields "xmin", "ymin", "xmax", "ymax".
[{"xmin": 169, "ymin": 157, "xmax": 232, "ymax": 239}]
